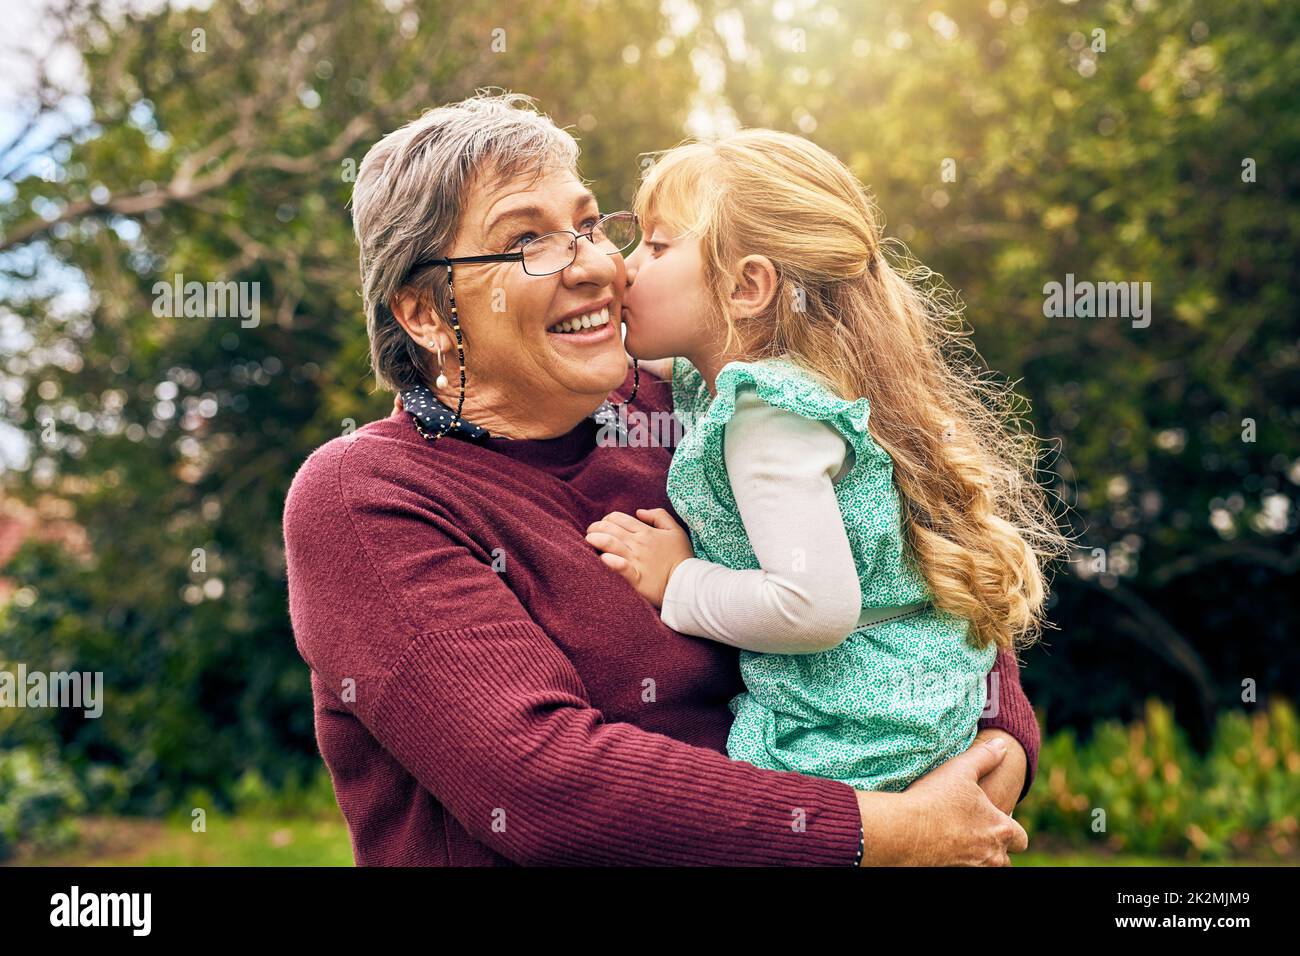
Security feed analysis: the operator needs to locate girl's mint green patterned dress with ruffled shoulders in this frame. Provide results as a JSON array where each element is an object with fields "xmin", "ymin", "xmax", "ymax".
[{"xmin": 668, "ymin": 358, "xmax": 997, "ymax": 791}]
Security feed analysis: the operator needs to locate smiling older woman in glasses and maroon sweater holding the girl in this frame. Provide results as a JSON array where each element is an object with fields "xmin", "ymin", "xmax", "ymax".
[{"xmin": 285, "ymin": 96, "xmax": 1039, "ymax": 865}]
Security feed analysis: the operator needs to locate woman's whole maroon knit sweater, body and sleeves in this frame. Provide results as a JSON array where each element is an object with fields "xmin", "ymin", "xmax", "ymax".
[{"xmin": 285, "ymin": 366, "xmax": 1039, "ymax": 866}]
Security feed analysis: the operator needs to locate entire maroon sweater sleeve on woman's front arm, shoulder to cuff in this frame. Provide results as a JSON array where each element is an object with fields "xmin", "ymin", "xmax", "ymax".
[{"xmin": 285, "ymin": 434, "xmax": 861, "ymax": 866}]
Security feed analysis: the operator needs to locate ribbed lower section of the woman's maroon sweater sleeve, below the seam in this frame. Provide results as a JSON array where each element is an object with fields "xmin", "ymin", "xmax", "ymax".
[{"xmin": 365, "ymin": 620, "xmax": 861, "ymax": 865}]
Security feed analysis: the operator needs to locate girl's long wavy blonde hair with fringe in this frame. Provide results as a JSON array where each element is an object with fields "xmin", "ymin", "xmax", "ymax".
[{"xmin": 636, "ymin": 130, "xmax": 1066, "ymax": 648}]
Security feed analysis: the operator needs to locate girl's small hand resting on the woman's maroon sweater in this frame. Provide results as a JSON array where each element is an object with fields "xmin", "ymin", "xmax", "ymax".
[{"xmin": 586, "ymin": 507, "xmax": 696, "ymax": 607}]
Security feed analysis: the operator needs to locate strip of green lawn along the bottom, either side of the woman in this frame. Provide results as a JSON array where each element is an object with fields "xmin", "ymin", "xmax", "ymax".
[{"xmin": 12, "ymin": 816, "xmax": 1268, "ymax": 866}]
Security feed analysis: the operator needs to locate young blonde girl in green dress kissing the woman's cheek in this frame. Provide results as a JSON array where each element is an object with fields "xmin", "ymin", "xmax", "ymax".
[{"xmin": 588, "ymin": 130, "xmax": 1062, "ymax": 790}]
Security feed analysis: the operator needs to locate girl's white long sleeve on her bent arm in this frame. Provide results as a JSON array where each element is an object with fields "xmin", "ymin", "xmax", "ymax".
[{"xmin": 660, "ymin": 385, "xmax": 862, "ymax": 654}]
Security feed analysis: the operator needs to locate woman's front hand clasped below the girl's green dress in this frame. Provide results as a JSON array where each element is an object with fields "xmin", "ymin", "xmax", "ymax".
[{"xmin": 858, "ymin": 737, "xmax": 1030, "ymax": 866}]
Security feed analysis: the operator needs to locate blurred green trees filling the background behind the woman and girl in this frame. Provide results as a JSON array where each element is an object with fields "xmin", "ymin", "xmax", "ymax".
[{"xmin": 0, "ymin": 0, "xmax": 1300, "ymax": 853}]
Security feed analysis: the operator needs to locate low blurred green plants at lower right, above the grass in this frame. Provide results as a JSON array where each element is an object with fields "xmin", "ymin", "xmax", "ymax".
[{"xmin": 1015, "ymin": 700, "xmax": 1300, "ymax": 862}]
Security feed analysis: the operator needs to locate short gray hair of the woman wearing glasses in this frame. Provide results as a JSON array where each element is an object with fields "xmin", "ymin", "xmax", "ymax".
[{"xmin": 352, "ymin": 91, "xmax": 579, "ymax": 390}]
